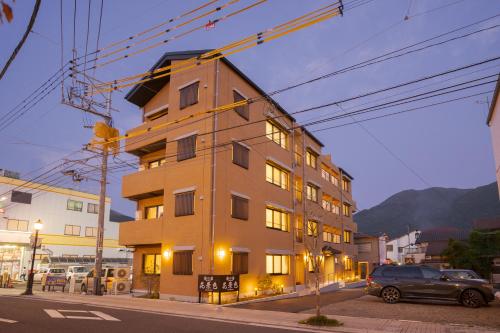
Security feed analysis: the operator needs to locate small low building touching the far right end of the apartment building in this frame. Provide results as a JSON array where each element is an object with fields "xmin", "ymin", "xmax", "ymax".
[{"xmin": 354, "ymin": 233, "xmax": 387, "ymax": 279}]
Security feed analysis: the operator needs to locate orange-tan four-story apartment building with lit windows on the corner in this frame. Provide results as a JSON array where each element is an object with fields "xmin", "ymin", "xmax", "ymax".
[{"xmin": 119, "ymin": 51, "xmax": 357, "ymax": 301}]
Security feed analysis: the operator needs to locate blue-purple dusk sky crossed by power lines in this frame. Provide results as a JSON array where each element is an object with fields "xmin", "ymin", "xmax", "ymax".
[{"xmin": 0, "ymin": 0, "xmax": 500, "ymax": 214}]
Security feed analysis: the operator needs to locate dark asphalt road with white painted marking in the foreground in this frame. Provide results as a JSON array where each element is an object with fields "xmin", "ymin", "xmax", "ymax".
[{"xmin": 0, "ymin": 296, "xmax": 310, "ymax": 333}]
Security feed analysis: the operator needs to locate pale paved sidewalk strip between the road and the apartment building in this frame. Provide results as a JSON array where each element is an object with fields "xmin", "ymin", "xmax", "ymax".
[{"xmin": 0, "ymin": 289, "xmax": 500, "ymax": 333}]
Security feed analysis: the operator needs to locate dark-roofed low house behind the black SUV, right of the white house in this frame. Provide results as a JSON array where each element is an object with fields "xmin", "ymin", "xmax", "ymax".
[{"xmin": 415, "ymin": 227, "xmax": 469, "ymax": 269}]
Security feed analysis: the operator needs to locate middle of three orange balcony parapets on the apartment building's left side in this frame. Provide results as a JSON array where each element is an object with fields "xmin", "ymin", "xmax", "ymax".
[{"xmin": 122, "ymin": 167, "xmax": 165, "ymax": 200}]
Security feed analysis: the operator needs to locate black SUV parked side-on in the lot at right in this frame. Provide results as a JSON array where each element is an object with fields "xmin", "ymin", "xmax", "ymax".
[{"xmin": 366, "ymin": 265, "xmax": 495, "ymax": 308}]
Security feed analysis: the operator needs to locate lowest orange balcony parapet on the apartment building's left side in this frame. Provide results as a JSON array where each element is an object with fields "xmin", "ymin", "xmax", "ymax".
[{"xmin": 118, "ymin": 218, "xmax": 163, "ymax": 246}]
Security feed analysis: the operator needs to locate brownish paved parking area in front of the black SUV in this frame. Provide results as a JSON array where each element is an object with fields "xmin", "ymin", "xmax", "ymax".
[{"xmin": 306, "ymin": 295, "xmax": 500, "ymax": 329}]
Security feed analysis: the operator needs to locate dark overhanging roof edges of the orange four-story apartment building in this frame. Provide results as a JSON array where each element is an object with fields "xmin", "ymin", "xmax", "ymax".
[{"xmin": 125, "ymin": 49, "xmax": 324, "ymax": 147}]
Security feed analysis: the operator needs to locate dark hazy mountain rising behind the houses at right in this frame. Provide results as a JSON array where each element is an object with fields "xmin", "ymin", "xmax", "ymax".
[{"xmin": 354, "ymin": 182, "xmax": 500, "ymax": 238}]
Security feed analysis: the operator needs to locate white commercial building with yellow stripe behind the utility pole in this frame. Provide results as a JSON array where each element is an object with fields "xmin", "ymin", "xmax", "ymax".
[{"xmin": 0, "ymin": 171, "xmax": 127, "ymax": 278}]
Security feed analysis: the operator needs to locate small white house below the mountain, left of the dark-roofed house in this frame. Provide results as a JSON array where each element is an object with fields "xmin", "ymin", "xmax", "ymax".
[{"xmin": 386, "ymin": 230, "xmax": 422, "ymax": 264}]
